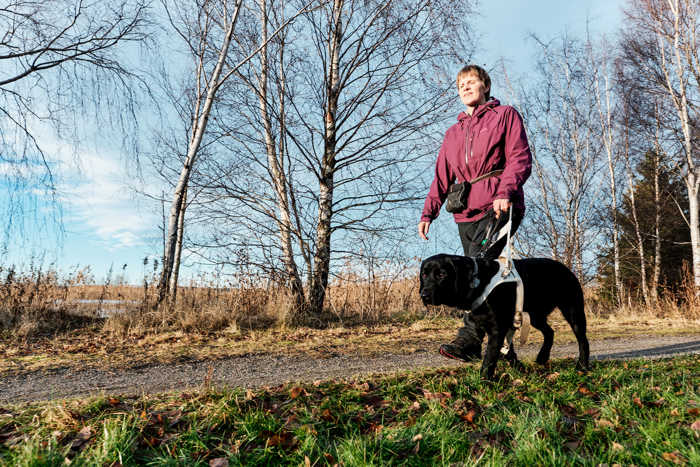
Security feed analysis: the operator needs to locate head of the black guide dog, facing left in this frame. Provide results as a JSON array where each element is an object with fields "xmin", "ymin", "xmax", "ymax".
[{"xmin": 420, "ymin": 255, "xmax": 474, "ymax": 306}]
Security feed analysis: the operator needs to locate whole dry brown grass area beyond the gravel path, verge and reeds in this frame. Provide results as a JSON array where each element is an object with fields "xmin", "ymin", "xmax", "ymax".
[{"xmin": 0, "ymin": 266, "xmax": 700, "ymax": 376}]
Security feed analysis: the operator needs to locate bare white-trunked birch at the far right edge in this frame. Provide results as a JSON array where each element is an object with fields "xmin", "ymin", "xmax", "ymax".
[{"xmin": 621, "ymin": 0, "xmax": 700, "ymax": 290}]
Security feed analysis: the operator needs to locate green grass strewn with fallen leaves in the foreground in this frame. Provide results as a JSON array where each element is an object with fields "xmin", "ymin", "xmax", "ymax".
[{"xmin": 0, "ymin": 356, "xmax": 700, "ymax": 467}]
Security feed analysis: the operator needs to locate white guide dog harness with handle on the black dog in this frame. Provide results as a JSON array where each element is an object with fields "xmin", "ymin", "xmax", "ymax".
[{"xmin": 467, "ymin": 205, "xmax": 530, "ymax": 355}]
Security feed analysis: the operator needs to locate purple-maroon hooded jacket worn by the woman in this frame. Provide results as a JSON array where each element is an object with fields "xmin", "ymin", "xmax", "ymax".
[{"xmin": 421, "ymin": 99, "xmax": 532, "ymax": 222}]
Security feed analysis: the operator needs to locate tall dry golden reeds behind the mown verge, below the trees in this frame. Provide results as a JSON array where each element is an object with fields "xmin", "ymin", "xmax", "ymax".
[{"xmin": 0, "ymin": 267, "xmax": 700, "ymax": 338}]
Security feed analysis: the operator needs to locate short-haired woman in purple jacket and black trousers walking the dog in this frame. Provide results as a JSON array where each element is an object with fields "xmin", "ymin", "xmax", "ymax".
[{"xmin": 418, "ymin": 65, "xmax": 532, "ymax": 361}]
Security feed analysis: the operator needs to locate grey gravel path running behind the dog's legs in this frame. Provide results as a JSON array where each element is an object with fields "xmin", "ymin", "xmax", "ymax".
[{"xmin": 0, "ymin": 335, "xmax": 700, "ymax": 403}]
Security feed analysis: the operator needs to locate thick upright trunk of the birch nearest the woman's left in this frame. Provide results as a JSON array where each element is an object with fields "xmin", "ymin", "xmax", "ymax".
[{"xmin": 310, "ymin": 0, "xmax": 343, "ymax": 315}]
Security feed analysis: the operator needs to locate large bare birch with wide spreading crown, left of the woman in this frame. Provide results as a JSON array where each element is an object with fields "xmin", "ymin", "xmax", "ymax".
[{"xmin": 189, "ymin": 0, "xmax": 471, "ymax": 315}]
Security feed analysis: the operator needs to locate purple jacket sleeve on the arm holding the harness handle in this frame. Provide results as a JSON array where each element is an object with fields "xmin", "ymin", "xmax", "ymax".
[{"xmin": 495, "ymin": 107, "xmax": 532, "ymax": 201}]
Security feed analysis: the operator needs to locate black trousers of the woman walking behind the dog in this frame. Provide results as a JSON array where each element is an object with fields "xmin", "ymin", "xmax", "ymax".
[{"xmin": 457, "ymin": 211, "xmax": 523, "ymax": 347}]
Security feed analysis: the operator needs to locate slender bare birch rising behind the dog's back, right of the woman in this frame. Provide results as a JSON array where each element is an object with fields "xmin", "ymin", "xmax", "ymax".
[{"xmin": 509, "ymin": 35, "xmax": 608, "ymax": 280}]
